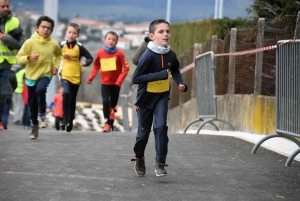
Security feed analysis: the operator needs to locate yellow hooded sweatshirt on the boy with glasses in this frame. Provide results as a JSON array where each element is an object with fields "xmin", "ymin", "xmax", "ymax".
[{"xmin": 17, "ymin": 32, "xmax": 62, "ymax": 80}]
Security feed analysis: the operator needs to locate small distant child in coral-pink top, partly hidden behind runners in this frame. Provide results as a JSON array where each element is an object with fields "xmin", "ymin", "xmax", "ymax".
[{"xmin": 47, "ymin": 86, "xmax": 65, "ymax": 130}]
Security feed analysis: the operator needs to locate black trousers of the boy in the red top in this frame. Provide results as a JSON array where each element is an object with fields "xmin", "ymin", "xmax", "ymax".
[{"xmin": 101, "ymin": 84, "xmax": 120, "ymax": 126}]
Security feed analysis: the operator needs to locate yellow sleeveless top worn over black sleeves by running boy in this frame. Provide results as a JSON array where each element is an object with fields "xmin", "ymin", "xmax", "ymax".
[{"xmin": 61, "ymin": 44, "xmax": 81, "ymax": 84}]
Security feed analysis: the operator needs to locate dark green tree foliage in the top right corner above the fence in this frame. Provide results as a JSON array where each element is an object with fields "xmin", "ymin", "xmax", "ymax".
[{"xmin": 247, "ymin": 0, "xmax": 300, "ymax": 20}]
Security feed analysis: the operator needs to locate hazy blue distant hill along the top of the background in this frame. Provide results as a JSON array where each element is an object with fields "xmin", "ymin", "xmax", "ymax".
[{"xmin": 11, "ymin": 0, "xmax": 251, "ymax": 23}]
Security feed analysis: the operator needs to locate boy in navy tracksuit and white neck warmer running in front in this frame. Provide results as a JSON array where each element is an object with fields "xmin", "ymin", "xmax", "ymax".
[{"xmin": 132, "ymin": 19, "xmax": 187, "ymax": 176}]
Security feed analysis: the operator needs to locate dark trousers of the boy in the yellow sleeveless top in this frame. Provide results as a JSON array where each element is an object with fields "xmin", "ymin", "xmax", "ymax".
[{"xmin": 61, "ymin": 79, "xmax": 79, "ymax": 122}]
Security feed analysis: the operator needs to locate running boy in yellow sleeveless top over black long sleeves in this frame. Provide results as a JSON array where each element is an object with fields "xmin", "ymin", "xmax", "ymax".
[{"xmin": 60, "ymin": 23, "xmax": 93, "ymax": 132}]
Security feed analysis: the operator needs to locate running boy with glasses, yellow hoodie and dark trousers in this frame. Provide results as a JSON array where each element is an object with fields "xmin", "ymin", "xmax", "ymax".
[{"xmin": 17, "ymin": 16, "xmax": 61, "ymax": 140}]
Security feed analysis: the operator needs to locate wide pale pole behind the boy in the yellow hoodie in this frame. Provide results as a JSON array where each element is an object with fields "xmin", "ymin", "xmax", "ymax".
[{"xmin": 44, "ymin": 0, "xmax": 58, "ymax": 105}]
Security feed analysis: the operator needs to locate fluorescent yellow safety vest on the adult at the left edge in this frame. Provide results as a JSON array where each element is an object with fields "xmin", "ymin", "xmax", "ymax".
[{"xmin": 0, "ymin": 17, "xmax": 19, "ymax": 65}]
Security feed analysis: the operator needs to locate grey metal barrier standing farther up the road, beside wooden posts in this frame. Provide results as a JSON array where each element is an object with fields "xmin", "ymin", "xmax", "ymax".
[{"xmin": 183, "ymin": 51, "xmax": 234, "ymax": 134}]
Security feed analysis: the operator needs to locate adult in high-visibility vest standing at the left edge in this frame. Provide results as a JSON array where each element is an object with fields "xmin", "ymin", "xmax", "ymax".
[{"xmin": 0, "ymin": 0, "xmax": 25, "ymax": 130}]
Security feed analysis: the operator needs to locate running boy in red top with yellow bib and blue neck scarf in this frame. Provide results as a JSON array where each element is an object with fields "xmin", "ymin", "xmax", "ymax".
[{"xmin": 87, "ymin": 31, "xmax": 129, "ymax": 132}]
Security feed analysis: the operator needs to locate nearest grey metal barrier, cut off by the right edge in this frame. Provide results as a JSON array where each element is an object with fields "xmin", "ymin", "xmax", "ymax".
[{"xmin": 251, "ymin": 40, "xmax": 300, "ymax": 166}]
